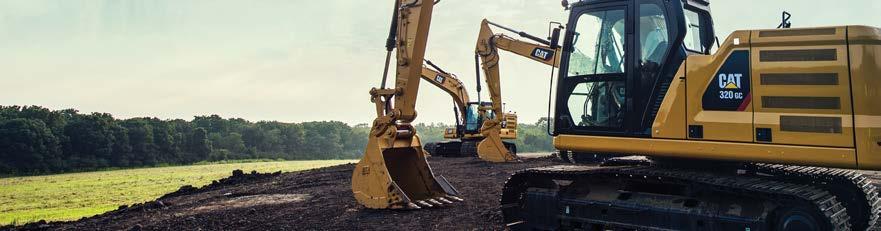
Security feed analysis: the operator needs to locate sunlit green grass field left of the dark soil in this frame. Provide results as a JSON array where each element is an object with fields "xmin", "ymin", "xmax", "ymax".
[{"xmin": 0, "ymin": 160, "xmax": 355, "ymax": 225}]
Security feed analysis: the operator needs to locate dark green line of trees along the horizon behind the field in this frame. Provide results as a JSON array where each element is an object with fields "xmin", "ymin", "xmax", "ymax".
[{"xmin": 0, "ymin": 106, "xmax": 553, "ymax": 175}]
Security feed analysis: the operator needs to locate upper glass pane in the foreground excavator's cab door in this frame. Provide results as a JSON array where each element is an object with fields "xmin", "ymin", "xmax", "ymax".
[{"xmin": 569, "ymin": 10, "xmax": 625, "ymax": 77}]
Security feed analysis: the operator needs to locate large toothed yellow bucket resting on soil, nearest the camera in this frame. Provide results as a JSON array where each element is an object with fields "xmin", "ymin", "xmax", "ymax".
[{"xmin": 352, "ymin": 122, "xmax": 462, "ymax": 209}]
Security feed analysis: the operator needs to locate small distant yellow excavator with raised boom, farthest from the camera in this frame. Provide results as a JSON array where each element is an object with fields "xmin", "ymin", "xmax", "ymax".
[{"xmin": 422, "ymin": 60, "xmax": 517, "ymax": 162}]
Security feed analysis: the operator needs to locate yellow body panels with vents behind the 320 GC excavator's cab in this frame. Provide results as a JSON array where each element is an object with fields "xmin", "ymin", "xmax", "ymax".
[{"xmin": 554, "ymin": 26, "xmax": 881, "ymax": 170}]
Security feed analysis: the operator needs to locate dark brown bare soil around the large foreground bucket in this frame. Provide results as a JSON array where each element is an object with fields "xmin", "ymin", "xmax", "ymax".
[{"xmin": 8, "ymin": 158, "xmax": 558, "ymax": 230}]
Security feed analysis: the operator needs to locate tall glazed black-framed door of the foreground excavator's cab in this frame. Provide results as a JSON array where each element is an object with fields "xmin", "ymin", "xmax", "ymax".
[{"xmin": 554, "ymin": 1, "xmax": 633, "ymax": 136}]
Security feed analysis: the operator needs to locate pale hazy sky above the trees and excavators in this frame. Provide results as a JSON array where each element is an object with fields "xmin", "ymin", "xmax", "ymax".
[{"xmin": 0, "ymin": 0, "xmax": 881, "ymax": 125}]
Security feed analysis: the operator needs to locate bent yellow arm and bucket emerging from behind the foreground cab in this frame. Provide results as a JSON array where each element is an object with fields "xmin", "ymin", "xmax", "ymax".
[{"xmin": 475, "ymin": 19, "xmax": 560, "ymax": 162}]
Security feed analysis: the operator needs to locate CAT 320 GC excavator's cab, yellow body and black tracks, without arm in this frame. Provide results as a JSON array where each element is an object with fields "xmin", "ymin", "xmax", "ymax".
[{"xmin": 353, "ymin": 0, "xmax": 881, "ymax": 230}]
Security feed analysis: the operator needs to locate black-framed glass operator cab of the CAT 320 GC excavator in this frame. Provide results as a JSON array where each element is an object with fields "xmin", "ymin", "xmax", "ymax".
[{"xmin": 554, "ymin": 0, "xmax": 715, "ymax": 137}]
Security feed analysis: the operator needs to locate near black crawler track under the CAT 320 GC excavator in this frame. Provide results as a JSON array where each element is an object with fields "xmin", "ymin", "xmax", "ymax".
[{"xmin": 501, "ymin": 165, "xmax": 852, "ymax": 231}]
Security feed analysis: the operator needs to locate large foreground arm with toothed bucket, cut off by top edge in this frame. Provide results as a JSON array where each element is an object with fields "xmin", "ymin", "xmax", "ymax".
[{"xmin": 352, "ymin": 0, "xmax": 461, "ymax": 209}]
